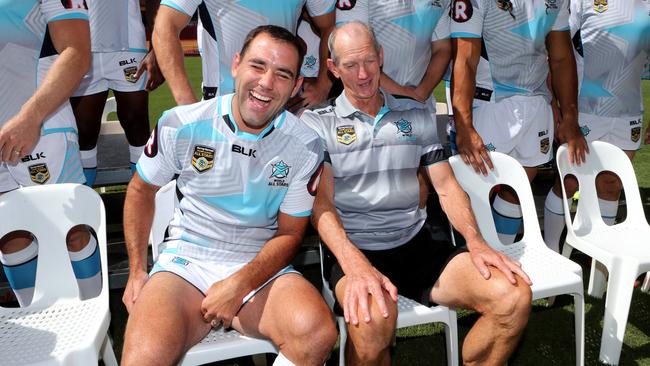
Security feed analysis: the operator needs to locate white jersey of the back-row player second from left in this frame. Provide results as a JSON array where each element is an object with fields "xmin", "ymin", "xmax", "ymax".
[{"xmin": 86, "ymin": 0, "xmax": 147, "ymax": 52}]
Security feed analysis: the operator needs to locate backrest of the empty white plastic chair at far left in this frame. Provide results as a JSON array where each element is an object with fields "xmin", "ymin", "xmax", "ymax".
[{"xmin": 0, "ymin": 184, "xmax": 108, "ymax": 308}]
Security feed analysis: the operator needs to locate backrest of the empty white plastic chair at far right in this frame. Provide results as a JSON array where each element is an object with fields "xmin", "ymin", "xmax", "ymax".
[{"xmin": 556, "ymin": 141, "xmax": 647, "ymax": 233}]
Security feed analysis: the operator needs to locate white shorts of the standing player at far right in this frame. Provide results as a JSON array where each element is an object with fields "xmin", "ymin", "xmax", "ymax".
[{"xmin": 578, "ymin": 113, "xmax": 643, "ymax": 151}]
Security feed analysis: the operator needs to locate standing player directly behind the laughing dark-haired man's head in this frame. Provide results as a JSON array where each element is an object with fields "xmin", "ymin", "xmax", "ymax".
[{"xmin": 153, "ymin": 0, "xmax": 334, "ymax": 108}]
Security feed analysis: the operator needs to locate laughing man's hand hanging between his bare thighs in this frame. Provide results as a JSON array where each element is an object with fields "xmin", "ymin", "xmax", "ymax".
[{"xmin": 201, "ymin": 276, "xmax": 249, "ymax": 329}]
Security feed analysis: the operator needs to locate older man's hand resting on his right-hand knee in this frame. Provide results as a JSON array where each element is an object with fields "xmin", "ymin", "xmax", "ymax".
[{"xmin": 468, "ymin": 242, "xmax": 533, "ymax": 285}]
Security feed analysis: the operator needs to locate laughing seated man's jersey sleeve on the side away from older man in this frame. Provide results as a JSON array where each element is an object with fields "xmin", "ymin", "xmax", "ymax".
[{"xmin": 136, "ymin": 110, "xmax": 182, "ymax": 187}]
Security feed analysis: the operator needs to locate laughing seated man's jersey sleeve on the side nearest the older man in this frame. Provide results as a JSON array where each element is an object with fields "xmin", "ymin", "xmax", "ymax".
[{"xmin": 280, "ymin": 136, "xmax": 323, "ymax": 217}]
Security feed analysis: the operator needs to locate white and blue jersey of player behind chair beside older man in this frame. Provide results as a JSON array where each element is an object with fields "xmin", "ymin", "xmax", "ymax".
[{"xmin": 451, "ymin": 0, "xmax": 569, "ymax": 101}]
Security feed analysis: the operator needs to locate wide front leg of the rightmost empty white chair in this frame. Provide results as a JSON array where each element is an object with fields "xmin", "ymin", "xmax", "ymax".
[{"xmin": 599, "ymin": 263, "xmax": 638, "ymax": 365}]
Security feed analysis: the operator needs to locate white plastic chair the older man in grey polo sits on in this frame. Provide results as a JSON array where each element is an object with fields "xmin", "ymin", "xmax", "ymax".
[{"xmin": 320, "ymin": 244, "xmax": 458, "ymax": 366}]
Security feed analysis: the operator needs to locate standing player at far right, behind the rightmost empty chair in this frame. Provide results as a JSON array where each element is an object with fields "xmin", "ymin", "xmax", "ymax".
[{"xmin": 544, "ymin": 0, "xmax": 650, "ymax": 251}]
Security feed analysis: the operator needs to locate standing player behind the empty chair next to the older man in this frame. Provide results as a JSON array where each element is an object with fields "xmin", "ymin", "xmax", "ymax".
[{"xmin": 451, "ymin": 0, "xmax": 587, "ymax": 244}]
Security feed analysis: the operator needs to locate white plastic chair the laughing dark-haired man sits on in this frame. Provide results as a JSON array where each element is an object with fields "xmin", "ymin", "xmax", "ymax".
[{"xmin": 149, "ymin": 180, "xmax": 278, "ymax": 366}]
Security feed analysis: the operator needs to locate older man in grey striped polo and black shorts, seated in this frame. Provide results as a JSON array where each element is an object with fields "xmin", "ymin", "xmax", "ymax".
[{"xmin": 302, "ymin": 22, "xmax": 531, "ymax": 365}]
